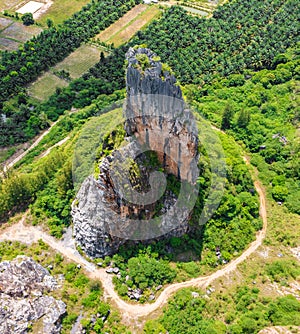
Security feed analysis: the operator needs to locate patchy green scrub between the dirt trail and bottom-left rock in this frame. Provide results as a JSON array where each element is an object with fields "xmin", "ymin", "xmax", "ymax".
[{"xmin": 0, "ymin": 240, "xmax": 129, "ymax": 334}]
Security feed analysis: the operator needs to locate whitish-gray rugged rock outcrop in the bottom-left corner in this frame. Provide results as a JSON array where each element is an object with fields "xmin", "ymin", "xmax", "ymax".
[{"xmin": 0, "ymin": 256, "xmax": 66, "ymax": 334}]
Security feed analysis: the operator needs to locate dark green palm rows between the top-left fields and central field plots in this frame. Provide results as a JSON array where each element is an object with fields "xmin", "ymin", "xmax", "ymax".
[{"xmin": 0, "ymin": 0, "xmax": 138, "ymax": 102}]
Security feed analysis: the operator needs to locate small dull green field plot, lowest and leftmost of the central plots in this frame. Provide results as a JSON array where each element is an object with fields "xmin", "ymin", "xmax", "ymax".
[{"xmin": 28, "ymin": 72, "xmax": 68, "ymax": 100}]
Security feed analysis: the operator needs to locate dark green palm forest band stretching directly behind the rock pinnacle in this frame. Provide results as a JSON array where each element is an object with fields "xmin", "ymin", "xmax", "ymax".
[{"xmin": 0, "ymin": 0, "xmax": 299, "ymax": 146}]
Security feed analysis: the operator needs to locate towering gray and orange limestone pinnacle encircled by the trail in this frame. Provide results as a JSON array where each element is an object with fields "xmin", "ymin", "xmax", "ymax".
[{"xmin": 72, "ymin": 48, "xmax": 199, "ymax": 258}]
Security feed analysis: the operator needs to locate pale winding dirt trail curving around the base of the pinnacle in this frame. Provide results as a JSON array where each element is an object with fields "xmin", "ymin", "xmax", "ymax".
[{"xmin": 0, "ymin": 164, "xmax": 267, "ymax": 323}]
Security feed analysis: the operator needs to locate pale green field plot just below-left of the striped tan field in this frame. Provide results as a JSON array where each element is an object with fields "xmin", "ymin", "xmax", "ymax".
[{"xmin": 53, "ymin": 44, "xmax": 100, "ymax": 79}]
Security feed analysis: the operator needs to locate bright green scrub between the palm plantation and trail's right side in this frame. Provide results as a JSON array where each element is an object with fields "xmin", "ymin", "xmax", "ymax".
[{"xmin": 187, "ymin": 45, "xmax": 300, "ymax": 214}]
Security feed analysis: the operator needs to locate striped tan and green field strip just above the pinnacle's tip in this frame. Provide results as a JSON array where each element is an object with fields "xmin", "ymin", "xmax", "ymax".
[{"xmin": 96, "ymin": 5, "xmax": 161, "ymax": 47}]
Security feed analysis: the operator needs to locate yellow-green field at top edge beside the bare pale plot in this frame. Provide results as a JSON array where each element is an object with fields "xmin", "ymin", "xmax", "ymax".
[{"xmin": 37, "ymin": 0, "xmax": 90, "ymax": 26}]
